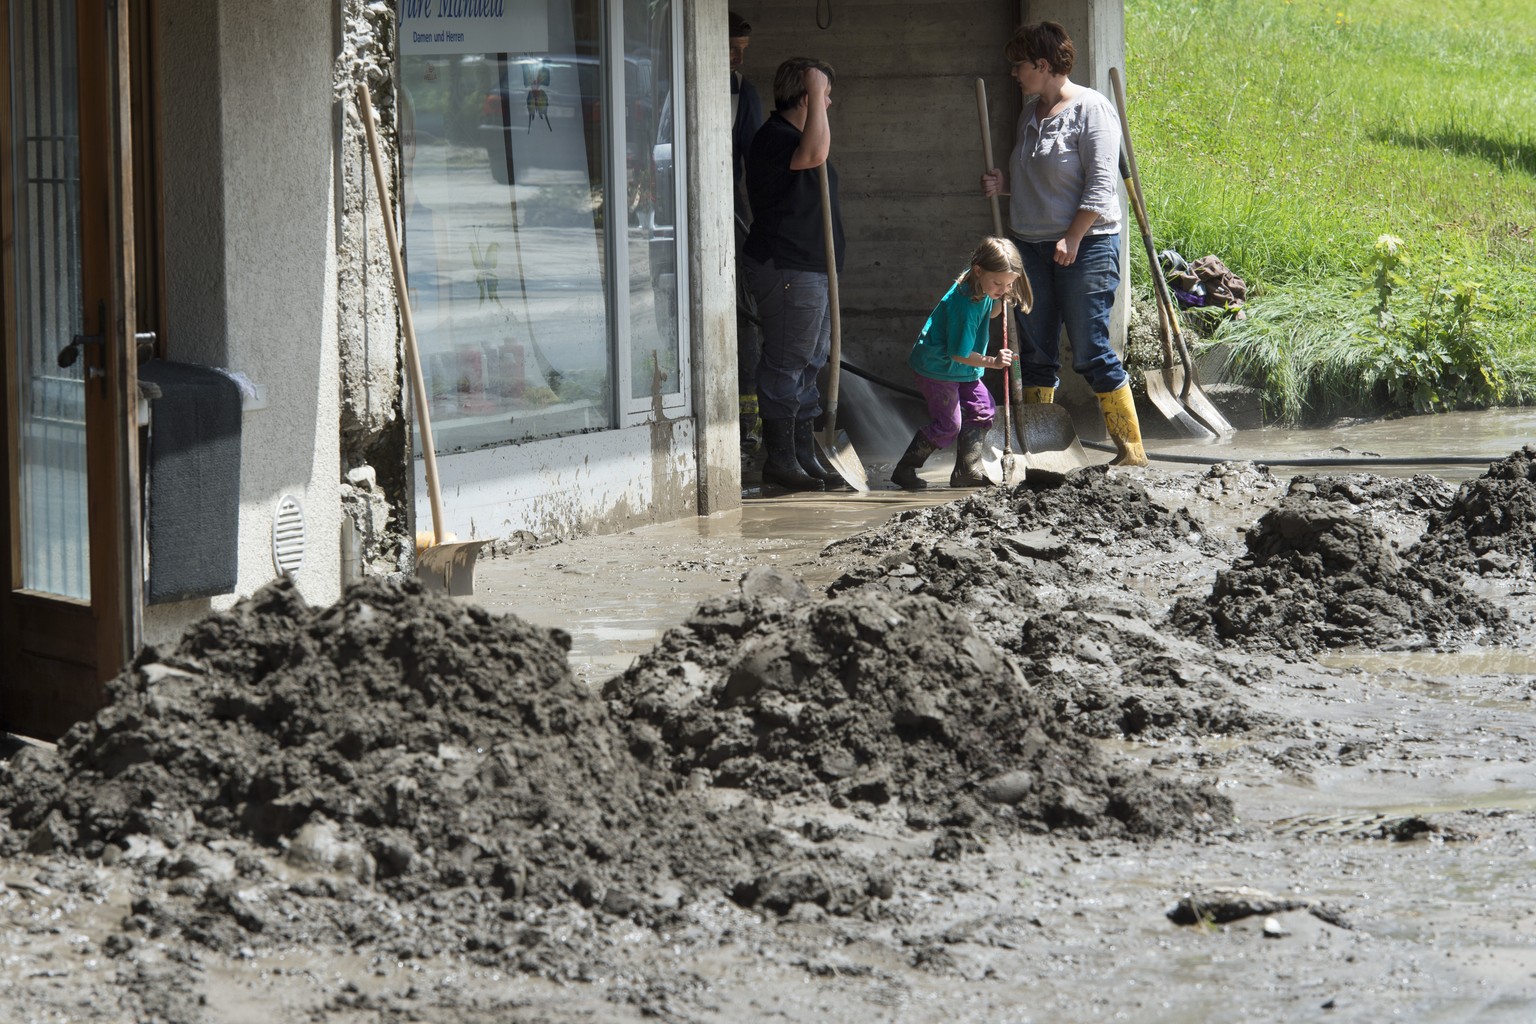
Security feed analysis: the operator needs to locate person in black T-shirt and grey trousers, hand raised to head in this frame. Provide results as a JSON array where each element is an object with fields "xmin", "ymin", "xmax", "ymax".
[{"xmin": 742, "ymin": 57, "xmax": 843, "ymax": 491}]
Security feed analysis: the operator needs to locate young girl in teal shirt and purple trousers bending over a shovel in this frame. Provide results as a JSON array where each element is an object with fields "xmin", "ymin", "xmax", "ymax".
[{"xmin": 891, "ymin": 238, "xmax": 1029, "ymax": 491}]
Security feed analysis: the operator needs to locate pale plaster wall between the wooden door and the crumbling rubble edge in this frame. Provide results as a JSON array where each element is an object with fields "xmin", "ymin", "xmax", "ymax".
[{"xmin": 144, "ymin": 0, "xmax": 341, "ymax": 643}]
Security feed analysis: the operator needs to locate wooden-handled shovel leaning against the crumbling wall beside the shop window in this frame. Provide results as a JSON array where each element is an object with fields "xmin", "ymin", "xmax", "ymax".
[{"xmin": 358, "ymin": 83, "xmax": 490, "ymax": 597}]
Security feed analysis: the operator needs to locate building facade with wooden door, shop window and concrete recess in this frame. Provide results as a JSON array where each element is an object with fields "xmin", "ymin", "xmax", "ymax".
[{"xmin": 0, "ymin": 0, "xmax": 1123, "ymax": 738}]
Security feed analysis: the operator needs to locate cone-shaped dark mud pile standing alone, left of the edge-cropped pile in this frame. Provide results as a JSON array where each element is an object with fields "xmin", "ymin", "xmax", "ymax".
[{"xmin": 1169, "ymin": 488, "xmax": 1508, "ymax": 654}]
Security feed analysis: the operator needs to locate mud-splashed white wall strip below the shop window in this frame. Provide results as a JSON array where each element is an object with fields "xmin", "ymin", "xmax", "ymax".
[{"xmin": 416, "ymin": 418, "xmax": 697, "ymax": 540}]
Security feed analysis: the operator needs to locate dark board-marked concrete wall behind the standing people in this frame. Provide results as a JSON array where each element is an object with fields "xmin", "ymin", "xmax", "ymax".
[{"xmin": 730, "ymin": 0, "xmax": 1124, "ymax": 429}]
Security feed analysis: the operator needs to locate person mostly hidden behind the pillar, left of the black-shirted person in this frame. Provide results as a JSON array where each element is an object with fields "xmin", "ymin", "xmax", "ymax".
[{"xmin": 728, "ymin": 11, "xmax": 763, "ymax": 456}]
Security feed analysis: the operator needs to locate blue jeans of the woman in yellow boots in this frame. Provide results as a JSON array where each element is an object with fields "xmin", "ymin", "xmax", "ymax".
[{"xmin": 1014, "ymin": 235, "xmax": 1126, "ymax": 395}]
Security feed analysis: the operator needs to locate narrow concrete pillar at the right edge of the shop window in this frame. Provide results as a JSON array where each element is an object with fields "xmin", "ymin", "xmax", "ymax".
[{"xmin": 688, "ymin": 0, "xmax": 742, "ymax": 516}]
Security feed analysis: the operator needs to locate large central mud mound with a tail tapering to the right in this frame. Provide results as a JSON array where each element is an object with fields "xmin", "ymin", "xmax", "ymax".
[{"xmin": 604, "ymin": 567, "xmax": 1232, "ymax": 835}]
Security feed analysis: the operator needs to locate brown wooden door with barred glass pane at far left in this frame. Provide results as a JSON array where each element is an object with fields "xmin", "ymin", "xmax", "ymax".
[{"xmin": 0, "ymin": 0, "xmax": 141, "ymax": 738}]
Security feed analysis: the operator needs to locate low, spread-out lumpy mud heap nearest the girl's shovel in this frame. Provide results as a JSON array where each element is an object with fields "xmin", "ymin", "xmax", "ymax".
[{"xmin": 828, "ymin": 465, "xmax": 1287, "ymax": 740}]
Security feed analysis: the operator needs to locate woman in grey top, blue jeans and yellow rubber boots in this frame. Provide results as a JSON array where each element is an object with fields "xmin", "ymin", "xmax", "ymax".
[{"xmin": 982, "ymin": 21, "xmax": 1147, "ymax": 465}]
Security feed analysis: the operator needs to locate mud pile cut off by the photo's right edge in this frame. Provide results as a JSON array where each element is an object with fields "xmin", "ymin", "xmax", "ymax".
[{"xmin": 1413, "ymin": 445, "xmax": 1536, "ymax": 577}]
